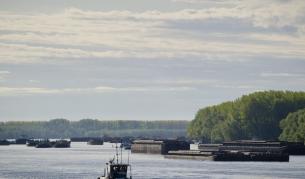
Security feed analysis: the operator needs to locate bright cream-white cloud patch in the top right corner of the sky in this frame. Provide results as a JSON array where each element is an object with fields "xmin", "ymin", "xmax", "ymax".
[{"xmin": 173, "ymin": 0, "xmax": 305, "ymax": 28}]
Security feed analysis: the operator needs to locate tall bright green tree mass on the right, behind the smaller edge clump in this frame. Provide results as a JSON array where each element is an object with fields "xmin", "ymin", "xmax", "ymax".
[{"xmin": 188, "ymin": 91, "xmax": 305, "ymax": 142}]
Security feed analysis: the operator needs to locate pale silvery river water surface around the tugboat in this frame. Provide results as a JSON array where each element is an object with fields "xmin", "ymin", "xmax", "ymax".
[{"xmin": 0, "ymin": 143, "xmax": 305, "ymax": 179}]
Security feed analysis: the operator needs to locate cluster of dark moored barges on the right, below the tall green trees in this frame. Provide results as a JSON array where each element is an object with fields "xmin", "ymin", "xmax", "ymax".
[{"xmin": 131, "ymin": 140, "xmax": 305, "ymax": 162}]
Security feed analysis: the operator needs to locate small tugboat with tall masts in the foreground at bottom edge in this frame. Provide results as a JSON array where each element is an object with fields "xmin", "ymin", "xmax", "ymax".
[{"xmin": 97, "ymin": 145, "xmax": 132, "ymax": 179}]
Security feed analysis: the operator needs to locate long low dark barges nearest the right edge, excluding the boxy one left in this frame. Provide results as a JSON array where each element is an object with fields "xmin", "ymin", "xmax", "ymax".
[{"xmin": 164, "ymin": 140, "xmax": 305, "ymax": 162}]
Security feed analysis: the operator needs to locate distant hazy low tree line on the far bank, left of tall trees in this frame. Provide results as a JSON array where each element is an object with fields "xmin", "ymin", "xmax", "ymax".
[{"xmin": 0, "ymin": 119, "xmax": 188, "ymax": 139}]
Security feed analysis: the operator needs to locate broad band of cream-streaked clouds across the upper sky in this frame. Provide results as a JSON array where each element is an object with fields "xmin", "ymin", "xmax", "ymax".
[{"xmin": 0, "ymin": 0, "xmax": 305, "ymax": 63}]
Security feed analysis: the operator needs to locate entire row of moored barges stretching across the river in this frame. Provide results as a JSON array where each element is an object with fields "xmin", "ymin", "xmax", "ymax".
[{"xmin": 0, "ymin": 137, "xmax": 305, "ymax": 162}]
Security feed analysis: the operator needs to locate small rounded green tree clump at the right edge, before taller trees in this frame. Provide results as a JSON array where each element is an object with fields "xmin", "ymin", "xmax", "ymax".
[{"xmin": 280, "ymin": 109, "xmax": 305, "ymax": 142}]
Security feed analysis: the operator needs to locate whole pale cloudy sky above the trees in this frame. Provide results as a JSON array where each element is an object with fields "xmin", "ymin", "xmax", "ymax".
[{"xmin": 0, "ymin": 0, "xmax": 305, "ymax": 121}]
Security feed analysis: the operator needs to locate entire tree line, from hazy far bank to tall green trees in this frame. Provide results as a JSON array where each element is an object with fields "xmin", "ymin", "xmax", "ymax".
[{"xmin": 0, "ymin": 91, "xmax": 305, "ymax": 143}]
